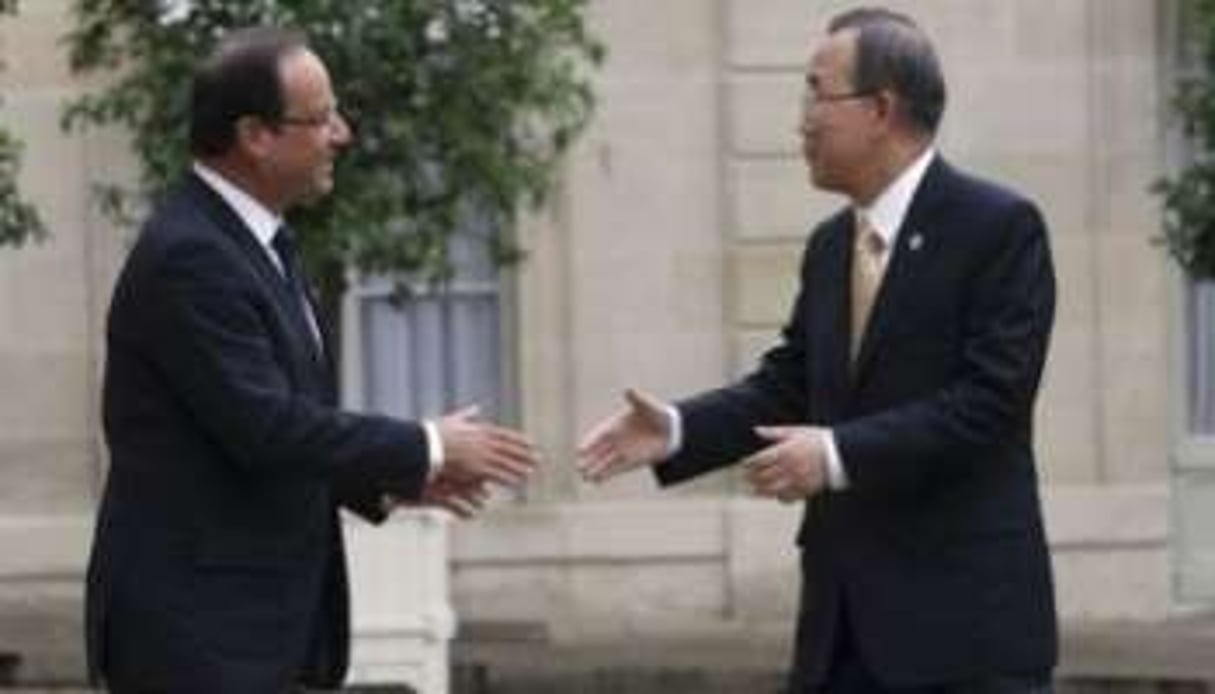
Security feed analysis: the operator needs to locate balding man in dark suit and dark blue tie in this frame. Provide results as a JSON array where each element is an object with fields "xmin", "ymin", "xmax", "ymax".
[{"xmin": 86, "ymin": 29, "xmax": 535, "ymax": 694}]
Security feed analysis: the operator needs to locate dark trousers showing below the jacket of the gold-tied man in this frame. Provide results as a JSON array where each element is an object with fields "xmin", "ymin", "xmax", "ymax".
[{"xmin": 806, "ymin": 609, "xmax": 1053, "ymax": 694}]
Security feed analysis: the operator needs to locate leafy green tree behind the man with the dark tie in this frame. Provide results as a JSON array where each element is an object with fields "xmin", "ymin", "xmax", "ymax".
[{"xmin": 63, "ymin": 0, "xmax": 604, "ymax": 298}]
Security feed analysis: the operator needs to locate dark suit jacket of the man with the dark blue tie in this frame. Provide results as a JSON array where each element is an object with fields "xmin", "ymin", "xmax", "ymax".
[{"xmin": 86, "ymin": 175, "xmax": 428, "ymax": 694}]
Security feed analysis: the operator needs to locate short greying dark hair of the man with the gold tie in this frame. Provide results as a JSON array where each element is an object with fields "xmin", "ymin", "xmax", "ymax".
[{"xmin": 827, "ymin": 7, "xmax": 945, "ymax": 135}]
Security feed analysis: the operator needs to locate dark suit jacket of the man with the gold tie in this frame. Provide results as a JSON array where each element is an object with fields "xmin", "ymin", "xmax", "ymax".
[{"xmin": 657, "ymin": 159, "xmax": 1056, "ymax": 692}]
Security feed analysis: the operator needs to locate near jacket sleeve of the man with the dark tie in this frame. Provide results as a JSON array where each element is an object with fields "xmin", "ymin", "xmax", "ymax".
[{"xmin": 140, "ymin": 233, "xmax": 428, "ymax": 500}]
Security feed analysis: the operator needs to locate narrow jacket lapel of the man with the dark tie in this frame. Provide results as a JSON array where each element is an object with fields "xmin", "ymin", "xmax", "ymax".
[{"xmin": 186, "ymin": 173, "xmax": 328, "ymax": 367}]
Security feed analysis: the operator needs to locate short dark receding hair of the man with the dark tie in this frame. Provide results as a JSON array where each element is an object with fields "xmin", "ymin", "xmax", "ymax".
[{"xmin": 190, "ymin": 27, "xmax": 307, "ymax": 157}]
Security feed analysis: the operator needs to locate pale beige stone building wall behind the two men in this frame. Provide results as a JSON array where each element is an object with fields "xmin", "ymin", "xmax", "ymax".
[{"xmin": 0, "ymin": 0, "xmax": 1200, "ymax": 685}]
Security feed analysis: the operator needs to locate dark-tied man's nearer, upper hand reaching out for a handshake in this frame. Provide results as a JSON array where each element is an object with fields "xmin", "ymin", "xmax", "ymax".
[{"xmin": 437, "ymin": 406, "xmax": 539, "ymax": 487}]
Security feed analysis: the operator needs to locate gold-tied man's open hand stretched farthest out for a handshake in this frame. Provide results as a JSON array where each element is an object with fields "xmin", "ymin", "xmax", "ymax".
[{"xmin": 578, "ymin": 388, "xmax": 671, "ymax": 483}]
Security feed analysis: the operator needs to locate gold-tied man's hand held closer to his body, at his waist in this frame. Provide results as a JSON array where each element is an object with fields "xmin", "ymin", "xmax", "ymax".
[{"xmin": 742, "ymin": 427, "xmax": 827, "ymax": 503}]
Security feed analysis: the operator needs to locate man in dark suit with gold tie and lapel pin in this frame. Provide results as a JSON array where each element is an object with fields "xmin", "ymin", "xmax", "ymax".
[{"xmin": 580, "ymin": 9, "xmax": 1056, "ymax": 694}]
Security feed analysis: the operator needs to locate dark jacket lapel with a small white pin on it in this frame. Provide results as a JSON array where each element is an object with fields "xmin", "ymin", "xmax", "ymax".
[{"xmin": 848, "ymin": 157, "xmax": 950, "ymax": 385}]
